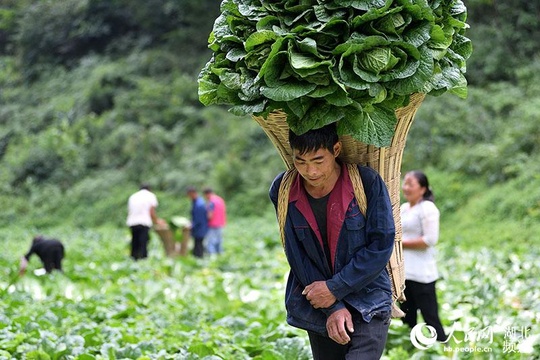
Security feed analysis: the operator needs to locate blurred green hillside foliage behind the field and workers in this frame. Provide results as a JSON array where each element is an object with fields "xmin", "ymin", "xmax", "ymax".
[{"xmin": 0, "ymin": 0, "xmax": 540, "ymax": 239}]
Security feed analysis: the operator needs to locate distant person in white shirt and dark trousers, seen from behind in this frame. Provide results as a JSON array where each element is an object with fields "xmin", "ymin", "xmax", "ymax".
[{"xmin": 126, "ymin": 184, "xmax": 158, "ymax": 260}]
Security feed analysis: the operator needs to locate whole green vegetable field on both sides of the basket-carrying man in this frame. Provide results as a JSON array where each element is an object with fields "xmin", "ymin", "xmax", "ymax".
[{"xmin": 0, "ymin": 216, "xmax": 540, "ymax": 360}]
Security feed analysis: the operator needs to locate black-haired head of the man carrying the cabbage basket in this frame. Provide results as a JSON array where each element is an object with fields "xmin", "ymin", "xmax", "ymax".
[{"xmin": 289, "ymin": 123, "xmax": 341, "ymax": 192}]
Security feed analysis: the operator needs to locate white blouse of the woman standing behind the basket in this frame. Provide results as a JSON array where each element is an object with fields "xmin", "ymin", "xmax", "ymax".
[{"xmin": 401, "ymin": 200, "xmax": 439, "ymax": 284}]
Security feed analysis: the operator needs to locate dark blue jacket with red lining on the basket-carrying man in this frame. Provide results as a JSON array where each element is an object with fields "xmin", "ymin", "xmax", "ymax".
[{"xmin": 270, "ymin": 166, "xmax": 395, "ymax": 335}]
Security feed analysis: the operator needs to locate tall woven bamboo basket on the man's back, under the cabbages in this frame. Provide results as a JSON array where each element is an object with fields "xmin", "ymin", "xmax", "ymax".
[{"xmin": 252, "ymin": 94, "xmax": 425, "ymax": 301}]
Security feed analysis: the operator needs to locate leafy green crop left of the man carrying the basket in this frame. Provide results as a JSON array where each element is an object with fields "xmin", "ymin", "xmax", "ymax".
[{"xmin": 0, "ymin": 221, "xmax": 309, "ymax": 360}]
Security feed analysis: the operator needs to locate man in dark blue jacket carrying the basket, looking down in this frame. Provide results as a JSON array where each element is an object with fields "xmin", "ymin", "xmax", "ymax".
[{"xmin": 269, "ymin": 123, "xmax": 395, "ymax": 360}]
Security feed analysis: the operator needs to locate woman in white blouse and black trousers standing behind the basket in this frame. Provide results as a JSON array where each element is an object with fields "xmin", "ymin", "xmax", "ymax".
[{"xmin": 401, "ymin": 170, "xmax": 447, "ymax": 342}]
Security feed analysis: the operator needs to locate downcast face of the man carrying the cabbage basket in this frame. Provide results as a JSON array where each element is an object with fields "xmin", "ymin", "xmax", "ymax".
[{"xmin": 293, "ymin": 143, "xmax": 341, "ymax": 187}]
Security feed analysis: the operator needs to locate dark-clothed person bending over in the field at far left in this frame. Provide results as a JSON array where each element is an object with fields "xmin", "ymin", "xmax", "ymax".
[{"xmin": 19, "ymin": 235, "xmax": 65, "ymax": 275}]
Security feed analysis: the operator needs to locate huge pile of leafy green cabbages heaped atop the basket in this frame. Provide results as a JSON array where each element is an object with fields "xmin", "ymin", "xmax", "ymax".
[{"xmin": 199, "ymin": 0, "xmax": 472, "ymax": 146}]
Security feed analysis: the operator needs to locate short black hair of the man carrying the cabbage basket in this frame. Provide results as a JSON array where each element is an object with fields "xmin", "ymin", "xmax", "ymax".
[{"xmin": 289, "ymin": 122, "xmax": 339, "ymax": 154}]
